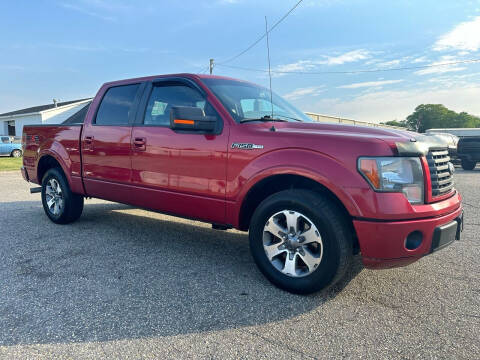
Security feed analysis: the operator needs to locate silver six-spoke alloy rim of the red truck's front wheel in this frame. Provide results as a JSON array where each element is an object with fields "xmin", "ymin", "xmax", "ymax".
[{"xmin": 263, "ymin": 210, "xmax": 323, "ymax": 277}]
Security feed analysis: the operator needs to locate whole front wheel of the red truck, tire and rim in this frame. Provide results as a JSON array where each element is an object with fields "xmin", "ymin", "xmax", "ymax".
[{"xmin": 249, "ymin": 190, "xmax": 353, "ymax": 294}]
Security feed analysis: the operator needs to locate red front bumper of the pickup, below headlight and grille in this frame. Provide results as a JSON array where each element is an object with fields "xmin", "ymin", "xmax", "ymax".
[{"xmin": 353, "ymin": 206, "xmax": 463, "ymax": 269}]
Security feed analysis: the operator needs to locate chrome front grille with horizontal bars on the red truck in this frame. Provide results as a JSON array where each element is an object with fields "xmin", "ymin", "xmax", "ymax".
[{"xmin": 427, "ymin": 149, "xmax": 453, "ymax": 198}]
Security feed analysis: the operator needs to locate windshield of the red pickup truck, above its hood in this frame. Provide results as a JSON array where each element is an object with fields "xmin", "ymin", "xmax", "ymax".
[{"xmin": 202, "ymin": 79, "xmax": 313, "ymax": 122}]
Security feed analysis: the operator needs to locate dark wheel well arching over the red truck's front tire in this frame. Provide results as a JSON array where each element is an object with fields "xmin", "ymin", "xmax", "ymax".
[{"xmin": 239, "ymin": 174, "xmax": 359, "ymax": 253}]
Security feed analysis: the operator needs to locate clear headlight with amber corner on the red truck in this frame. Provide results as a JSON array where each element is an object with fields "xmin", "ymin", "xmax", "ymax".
[{"xmin": 358, "ymin": 157, "xmax": 424, "ymax": 204}]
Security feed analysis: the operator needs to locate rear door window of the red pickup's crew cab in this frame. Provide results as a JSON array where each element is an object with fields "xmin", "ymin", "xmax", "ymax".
[{"xmin": 95, "ymin": 84, "xmax": 140, "ymax": 126}]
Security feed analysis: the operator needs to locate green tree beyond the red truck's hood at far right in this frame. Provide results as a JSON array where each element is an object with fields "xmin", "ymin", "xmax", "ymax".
[{"xmin": 406, "ymin": 104, "xmax": 480, "ymax": 133}]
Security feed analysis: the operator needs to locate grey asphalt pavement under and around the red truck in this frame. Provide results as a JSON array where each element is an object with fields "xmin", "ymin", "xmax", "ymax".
[{"xmin": 0, "ymin": 167, "xmax": 480, "ymax": 359}]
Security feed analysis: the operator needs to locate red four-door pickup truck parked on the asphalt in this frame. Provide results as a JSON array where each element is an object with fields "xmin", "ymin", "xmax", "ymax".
[{"xmin": 22, "ymin": 74, "xmax": 463, "ymax": 293}]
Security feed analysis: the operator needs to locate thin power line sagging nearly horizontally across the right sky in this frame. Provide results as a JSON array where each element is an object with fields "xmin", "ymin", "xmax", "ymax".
[{"xmin": 217, "ymin": 59, "xmax": 480, "ymax": 75}]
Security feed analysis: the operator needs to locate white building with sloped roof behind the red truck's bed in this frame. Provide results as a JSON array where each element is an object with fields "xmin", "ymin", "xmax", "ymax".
[{"xmin": 0, "ymin": 99, "xmax": 91, "ymax": 136}]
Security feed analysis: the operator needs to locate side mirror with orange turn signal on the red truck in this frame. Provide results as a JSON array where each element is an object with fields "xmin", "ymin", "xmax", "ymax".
[{"xmin": 170, "ymin": 106, "xmax": 217, "ymax": 133}]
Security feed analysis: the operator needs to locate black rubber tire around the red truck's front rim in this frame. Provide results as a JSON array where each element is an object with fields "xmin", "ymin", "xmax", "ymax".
[{"xmin": 249, "ymin": 190, "xmax": 353, "ymax": 294}]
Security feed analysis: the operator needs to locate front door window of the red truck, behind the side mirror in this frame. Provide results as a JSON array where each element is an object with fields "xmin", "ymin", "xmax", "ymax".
[{"xmin": 143, "ymin": 84, "xmax": 218, "ymax": 126}]
